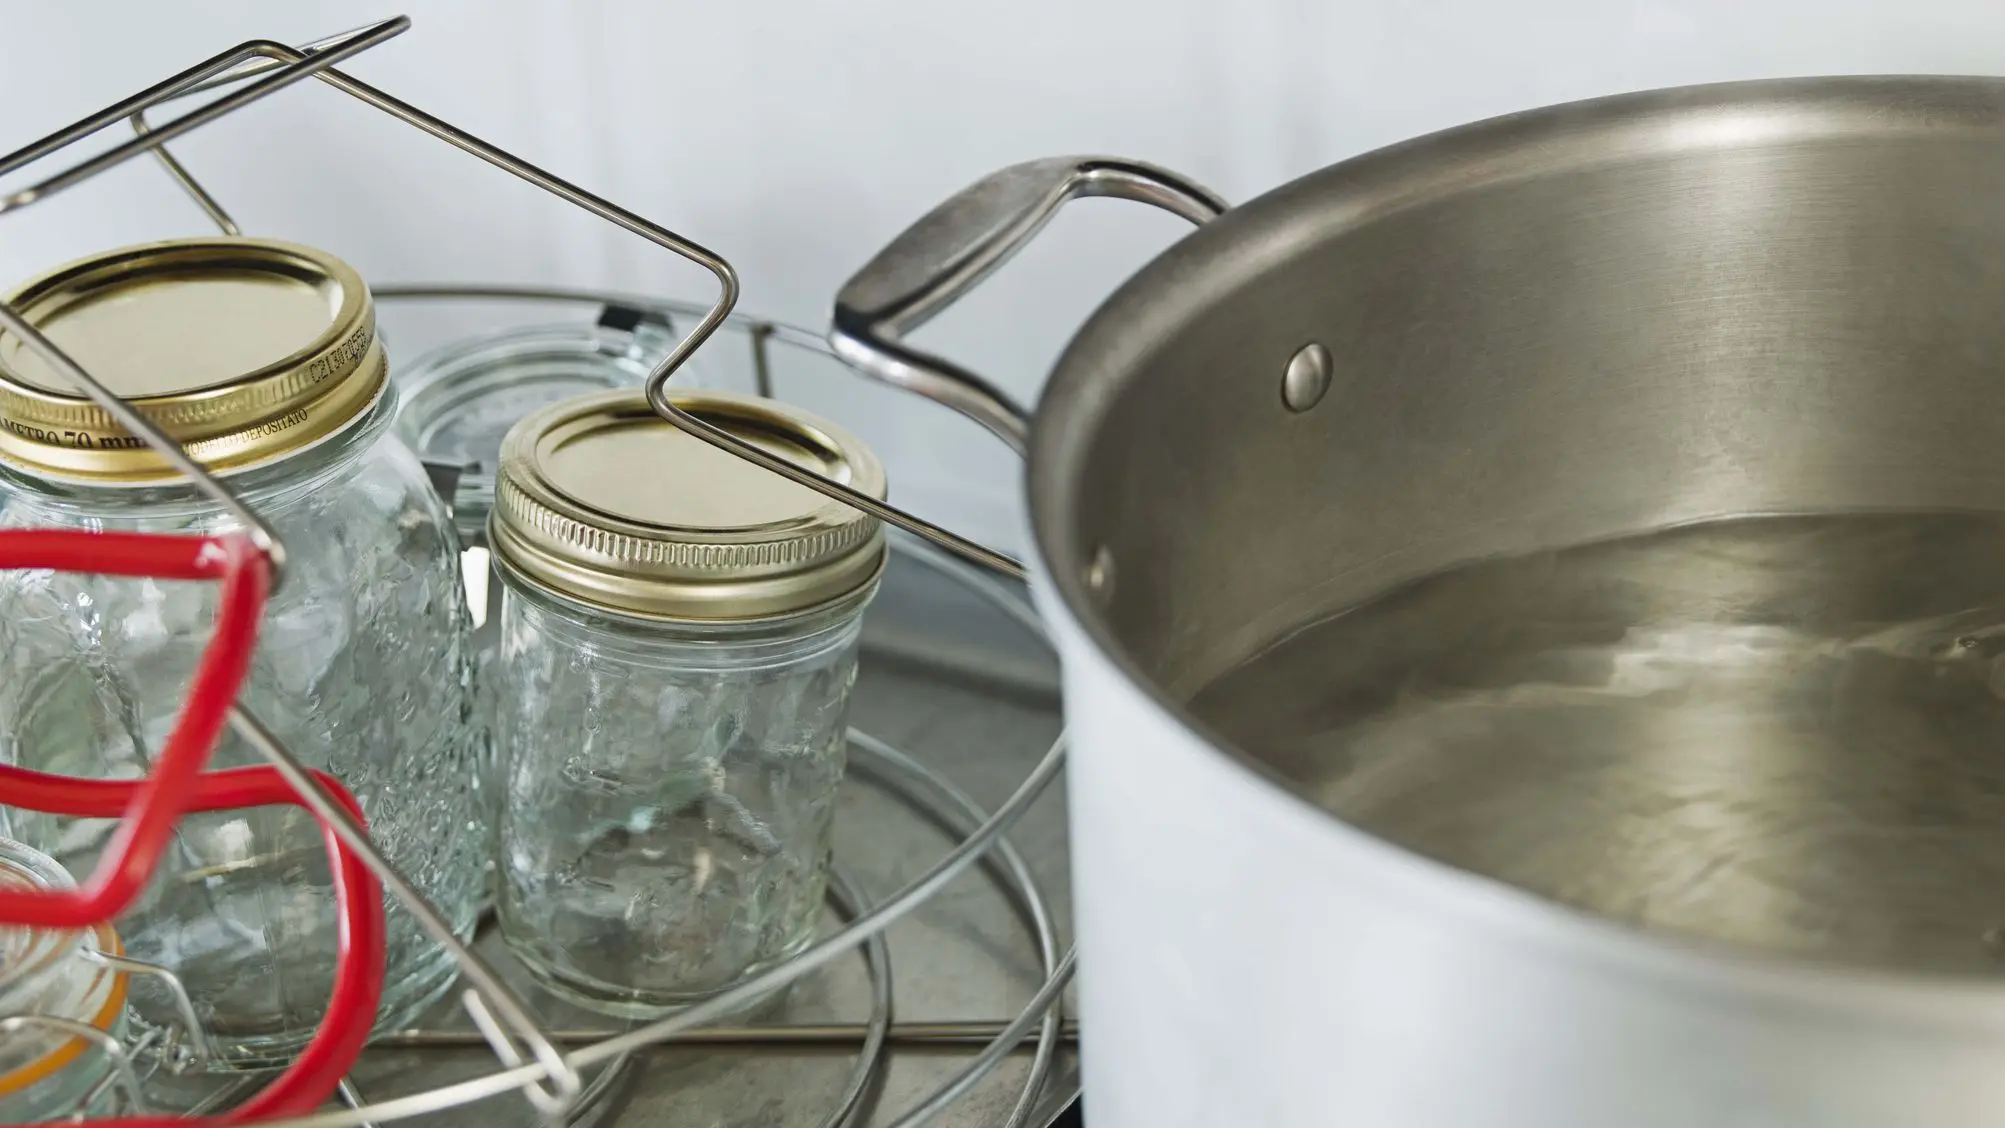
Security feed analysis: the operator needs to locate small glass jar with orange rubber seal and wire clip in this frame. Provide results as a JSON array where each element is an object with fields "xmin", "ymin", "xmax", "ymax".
[{"xmin": 0, "ymin": 837, "xmax": 126, "ymax": 1124}]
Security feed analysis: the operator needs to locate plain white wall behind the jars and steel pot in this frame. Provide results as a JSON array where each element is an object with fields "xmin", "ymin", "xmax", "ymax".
[{"xmin": 0, "ymin": 0, "xmax": 2005, "ymax": 556}]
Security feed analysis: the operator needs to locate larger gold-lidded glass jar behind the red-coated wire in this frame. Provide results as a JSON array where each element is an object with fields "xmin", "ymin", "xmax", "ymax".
[{"xmin": 0, "ymin": 238, "xmax": 489, "ymax": 1068}]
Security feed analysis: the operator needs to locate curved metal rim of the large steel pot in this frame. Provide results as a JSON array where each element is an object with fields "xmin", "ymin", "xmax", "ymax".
[{"xmin": 1027, "ymin": 74, "xmax": 2005, "ymax": 1013}]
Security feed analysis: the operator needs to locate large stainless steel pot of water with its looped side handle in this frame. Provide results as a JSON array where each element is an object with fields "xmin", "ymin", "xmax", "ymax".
[{"xmin": 834, "ymin": 78, "xmax": 2005, "ymax": 1128}]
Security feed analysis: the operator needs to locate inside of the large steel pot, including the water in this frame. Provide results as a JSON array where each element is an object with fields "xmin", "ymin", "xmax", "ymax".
[{"xmin": 1033, "ymin": 78, "xmax": 2005, "ymax": 974}]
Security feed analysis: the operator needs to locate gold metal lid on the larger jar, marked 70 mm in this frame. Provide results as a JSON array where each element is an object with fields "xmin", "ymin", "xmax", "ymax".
[{"xmin": 0, "ymin": 236, "xmax": 387, "ymax": 483}]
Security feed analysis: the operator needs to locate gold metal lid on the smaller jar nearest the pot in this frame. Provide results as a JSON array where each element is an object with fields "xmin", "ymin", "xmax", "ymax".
[{"xmin": 487, "ymin": 389, "xmax": 884, "ymax": 621}]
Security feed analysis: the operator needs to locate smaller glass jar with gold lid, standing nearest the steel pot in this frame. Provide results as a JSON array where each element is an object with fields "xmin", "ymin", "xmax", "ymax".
[{"xmin": 487, "ymin": 391, "xmax": 884, "ymax": 1018}]
